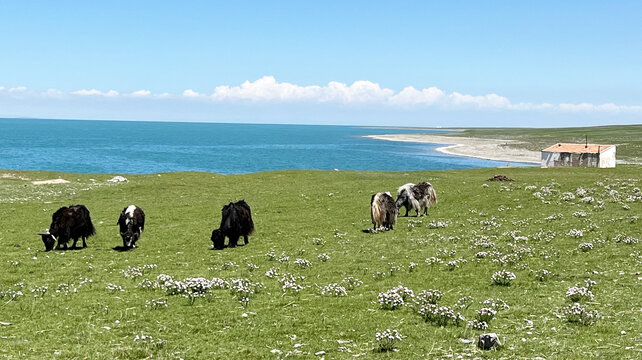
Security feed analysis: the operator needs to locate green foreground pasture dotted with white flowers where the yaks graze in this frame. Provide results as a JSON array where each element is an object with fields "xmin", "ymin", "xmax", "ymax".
[{"xmin": 0, "ymin": 167, "xmax": 642, "ymax": 359}]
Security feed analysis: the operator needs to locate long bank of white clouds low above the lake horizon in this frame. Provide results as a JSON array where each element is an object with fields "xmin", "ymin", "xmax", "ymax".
[{"xmin": 0, "ymin": 76, "xmax": 642, "ymax": 113}]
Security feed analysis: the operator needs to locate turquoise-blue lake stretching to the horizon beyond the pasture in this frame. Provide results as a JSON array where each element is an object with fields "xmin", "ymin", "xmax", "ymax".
[{"xmin": 0, "ymin": 119, "xmax": 527, "ymax": 174}]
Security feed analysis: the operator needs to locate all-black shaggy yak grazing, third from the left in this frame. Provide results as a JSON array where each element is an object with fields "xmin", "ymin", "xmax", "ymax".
[{"xmin": 211, "ymin": 200, "xmax": 254, "ymax": 250}]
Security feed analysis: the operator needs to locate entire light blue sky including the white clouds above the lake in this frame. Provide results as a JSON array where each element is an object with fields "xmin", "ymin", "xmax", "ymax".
[{"xmin": 0, "ymin": 0, "xmax": 642, "ymax": 127}]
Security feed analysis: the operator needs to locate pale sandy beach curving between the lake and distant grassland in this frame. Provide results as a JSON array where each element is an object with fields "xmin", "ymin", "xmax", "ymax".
[{"xmin": 366, "ymin": 134, "xmax": 540, "ymax": 164}]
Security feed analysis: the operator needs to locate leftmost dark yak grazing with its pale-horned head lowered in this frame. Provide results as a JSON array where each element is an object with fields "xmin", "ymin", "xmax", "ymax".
[{"xmin": 38, "ymin": 205, "xmax": 96, "ymax": 251}]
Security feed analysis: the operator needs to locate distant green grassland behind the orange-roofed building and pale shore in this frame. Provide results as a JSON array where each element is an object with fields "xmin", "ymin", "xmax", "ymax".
[{"xmin": 454, "ymin": 125, "xmax": 642, "ymax": 164}]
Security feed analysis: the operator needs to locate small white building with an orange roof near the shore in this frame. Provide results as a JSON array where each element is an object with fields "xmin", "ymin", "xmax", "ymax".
[{"xmin": 542, "ymin": 144, "xmax": 615, "ymax": 168}]
